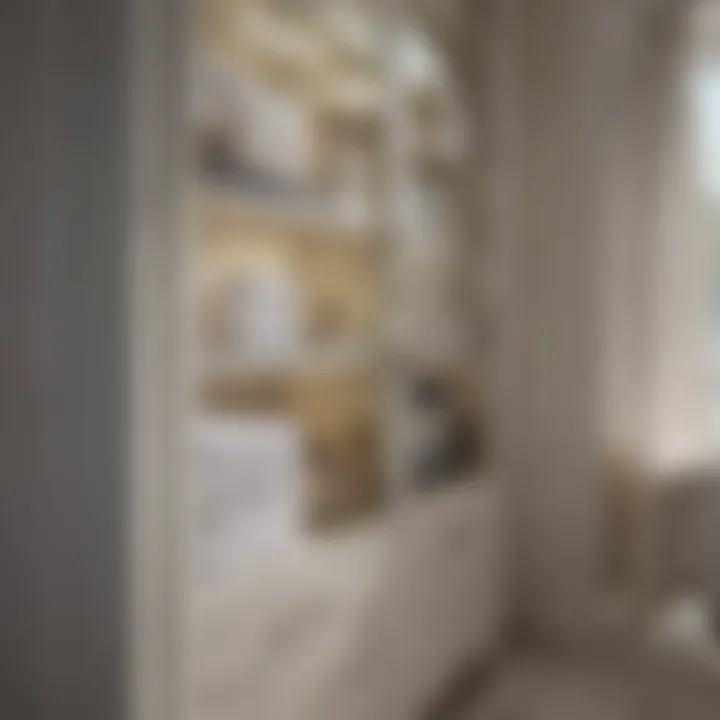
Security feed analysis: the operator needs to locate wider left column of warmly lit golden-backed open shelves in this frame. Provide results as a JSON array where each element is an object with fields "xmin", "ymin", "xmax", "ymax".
[{"xmin": 195, "ymin": 0, "xmax": 387, "ymax": 530}]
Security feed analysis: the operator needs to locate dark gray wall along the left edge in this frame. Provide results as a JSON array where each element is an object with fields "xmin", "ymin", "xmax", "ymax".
[{"xmin": 0, "ymin": 0, "xmax": 128, "ymax": 720}]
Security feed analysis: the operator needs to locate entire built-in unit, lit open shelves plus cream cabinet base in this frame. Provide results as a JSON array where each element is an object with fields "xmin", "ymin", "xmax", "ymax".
[{"xmin": 191, "ymin": 0, "xmax": 500, "ymax": 718}]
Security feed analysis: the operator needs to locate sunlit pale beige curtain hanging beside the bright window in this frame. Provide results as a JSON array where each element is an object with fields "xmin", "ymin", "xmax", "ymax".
[{"xmin": 604, "ymin": 1, "xmax": 709, "ymax": 465}]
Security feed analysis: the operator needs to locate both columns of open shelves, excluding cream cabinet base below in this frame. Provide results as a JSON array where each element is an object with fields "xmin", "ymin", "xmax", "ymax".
[{"xmin": 194, "ymin": 0, "xmax": 486, "ymax": 529}]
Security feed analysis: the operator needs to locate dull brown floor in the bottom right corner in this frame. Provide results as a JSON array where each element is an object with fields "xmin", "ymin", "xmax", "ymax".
[{"xmin": 457, "ymin": 599, "xmax": 720, "ymax": 720}]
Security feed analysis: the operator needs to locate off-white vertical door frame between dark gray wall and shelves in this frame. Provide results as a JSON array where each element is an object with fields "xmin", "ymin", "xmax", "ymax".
[{"xmin": 127, "ymin": 0, "xmax": 191, "ymax": 720}]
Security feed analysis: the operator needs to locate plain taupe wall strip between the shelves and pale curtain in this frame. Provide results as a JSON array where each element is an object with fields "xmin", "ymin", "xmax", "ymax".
[{"xmin": 498, "ymin": 1, "xmax": 608, "ymax": 641}]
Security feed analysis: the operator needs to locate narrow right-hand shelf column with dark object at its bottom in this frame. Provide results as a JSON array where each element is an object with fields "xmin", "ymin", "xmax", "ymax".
[{"xmin": 389, "ymin": 16, "xmax": 484, "ymax": 497}]
